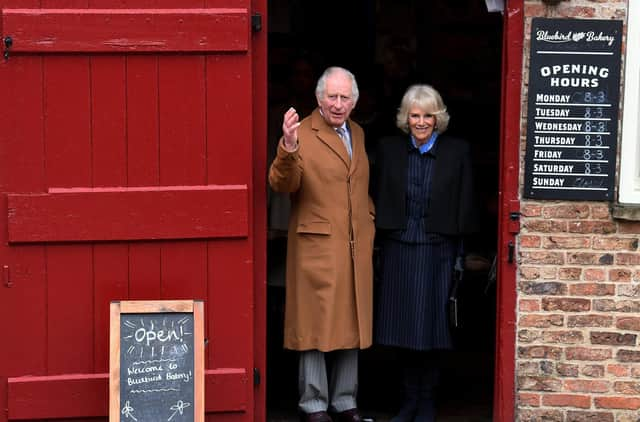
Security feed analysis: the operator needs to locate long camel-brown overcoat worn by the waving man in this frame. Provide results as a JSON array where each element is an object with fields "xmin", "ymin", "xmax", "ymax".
[{"xmin": 269, "ymin": 109, "xmax": 375, "ymax": 352}]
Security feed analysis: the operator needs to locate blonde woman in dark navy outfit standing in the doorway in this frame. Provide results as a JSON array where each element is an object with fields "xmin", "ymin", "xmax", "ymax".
[{"xmin": 372, "ymin": 85, "xmax": 477, "ymax": 422}]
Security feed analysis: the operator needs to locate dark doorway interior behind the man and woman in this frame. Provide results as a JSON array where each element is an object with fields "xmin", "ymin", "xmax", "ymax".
[{"xmin": 267, "ymin": 0, "xmax": 502, "ymax": 421}]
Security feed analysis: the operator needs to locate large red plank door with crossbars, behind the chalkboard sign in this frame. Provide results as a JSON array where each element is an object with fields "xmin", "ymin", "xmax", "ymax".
[{"xmin": 0, "ymin": 0, "xmax": 266, "ymax": 422}]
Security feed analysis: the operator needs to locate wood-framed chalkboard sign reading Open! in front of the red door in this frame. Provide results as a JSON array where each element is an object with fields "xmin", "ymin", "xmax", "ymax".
[{"xmin": 109, "ymin": 300, "xmax": 204, "ymax": 422}]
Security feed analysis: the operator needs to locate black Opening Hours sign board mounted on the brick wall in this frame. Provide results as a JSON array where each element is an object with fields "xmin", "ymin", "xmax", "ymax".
[{"xmin": 524, "ymin": 18, "xmax": 622, "ymax": 200}]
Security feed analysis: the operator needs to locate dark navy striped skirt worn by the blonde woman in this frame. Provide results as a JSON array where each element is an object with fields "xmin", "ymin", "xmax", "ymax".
[{"xmin": 374, "ymin": 236, "xmax": 456, "ymax": 350}]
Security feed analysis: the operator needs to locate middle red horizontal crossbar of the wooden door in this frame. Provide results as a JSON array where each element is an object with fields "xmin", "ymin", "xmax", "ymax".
[{"xmin": 8, "ymin": 186, "xmax": 248, "ymax": 242}]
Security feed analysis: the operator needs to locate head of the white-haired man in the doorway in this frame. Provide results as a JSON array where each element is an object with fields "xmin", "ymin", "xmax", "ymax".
[{"xmin": 318, "ymin": 72, "xmax": 356, "ymax": 127}]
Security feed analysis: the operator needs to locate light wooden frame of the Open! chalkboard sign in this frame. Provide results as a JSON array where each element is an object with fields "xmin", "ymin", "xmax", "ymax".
[{"xmin": 109, "ymin": 300, "xmax": 204, "ymax": 422}]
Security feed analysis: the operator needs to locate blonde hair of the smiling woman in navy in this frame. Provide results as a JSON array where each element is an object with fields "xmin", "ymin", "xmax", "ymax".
[{"xmin": 396, "ymin": 85, "xmax": 449, "ymax": 133}]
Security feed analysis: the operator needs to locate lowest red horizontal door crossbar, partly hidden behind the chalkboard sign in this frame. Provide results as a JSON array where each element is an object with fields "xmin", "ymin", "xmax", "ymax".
[{"xmin": 3, "ymin": 368, "xmax": 251, "ymax": 420}]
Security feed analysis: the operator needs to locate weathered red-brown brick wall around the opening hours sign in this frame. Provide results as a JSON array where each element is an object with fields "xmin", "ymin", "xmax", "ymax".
[{"xmin": 516, "ymin": 0, "xmax": 640, "ymax": 422}]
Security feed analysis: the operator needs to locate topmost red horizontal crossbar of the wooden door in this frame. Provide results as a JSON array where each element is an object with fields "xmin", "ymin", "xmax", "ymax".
[{"xmin": 2, "ymin": 8, "xmax": 249, "ymax": 53}]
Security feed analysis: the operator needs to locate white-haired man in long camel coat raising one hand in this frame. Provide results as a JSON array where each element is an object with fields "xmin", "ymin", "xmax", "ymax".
[{"xmin": 269, "ymin": 67, "xmax": 374, "ymax": 422}]
